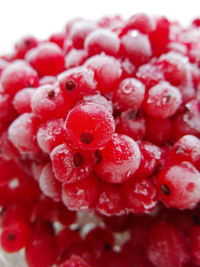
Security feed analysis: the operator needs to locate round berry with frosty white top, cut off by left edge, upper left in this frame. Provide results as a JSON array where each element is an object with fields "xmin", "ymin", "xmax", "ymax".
[{"xmin": 1, "ymin": 60, "xmax": 38, "ymax": 95}]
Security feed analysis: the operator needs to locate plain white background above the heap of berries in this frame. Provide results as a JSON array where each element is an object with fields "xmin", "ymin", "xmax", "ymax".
[{"xmin": 0, "ymin": 0, "xmax": 200, "ymax": 53}]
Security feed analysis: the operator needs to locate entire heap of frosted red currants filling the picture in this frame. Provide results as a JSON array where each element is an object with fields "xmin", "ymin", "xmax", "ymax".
[{"xmin": 0, "ymin": 14, "xmax": 200, "ymax": 267}]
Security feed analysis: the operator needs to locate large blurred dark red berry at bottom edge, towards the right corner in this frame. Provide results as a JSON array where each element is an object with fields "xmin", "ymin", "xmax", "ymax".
[{"xmin": 147, "ymin": 221, "xmax": 189, "ymax": 267}]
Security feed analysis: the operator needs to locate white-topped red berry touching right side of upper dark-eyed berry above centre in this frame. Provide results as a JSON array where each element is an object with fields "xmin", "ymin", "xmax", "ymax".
[{"xmin": 84, "ymin": 54, "xmax": 122, "ymax": 93}]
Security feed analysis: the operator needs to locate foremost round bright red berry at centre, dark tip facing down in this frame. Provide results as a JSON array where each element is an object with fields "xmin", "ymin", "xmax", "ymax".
[{"xmin": 65, "ymin": 103, "xmax": 115, "ymax": 150}]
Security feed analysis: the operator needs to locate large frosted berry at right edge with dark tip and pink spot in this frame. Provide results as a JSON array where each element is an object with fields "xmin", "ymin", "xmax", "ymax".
[{"xmin": 157, "ymin": 161, "xmax": 200, "ymax": 209}]
